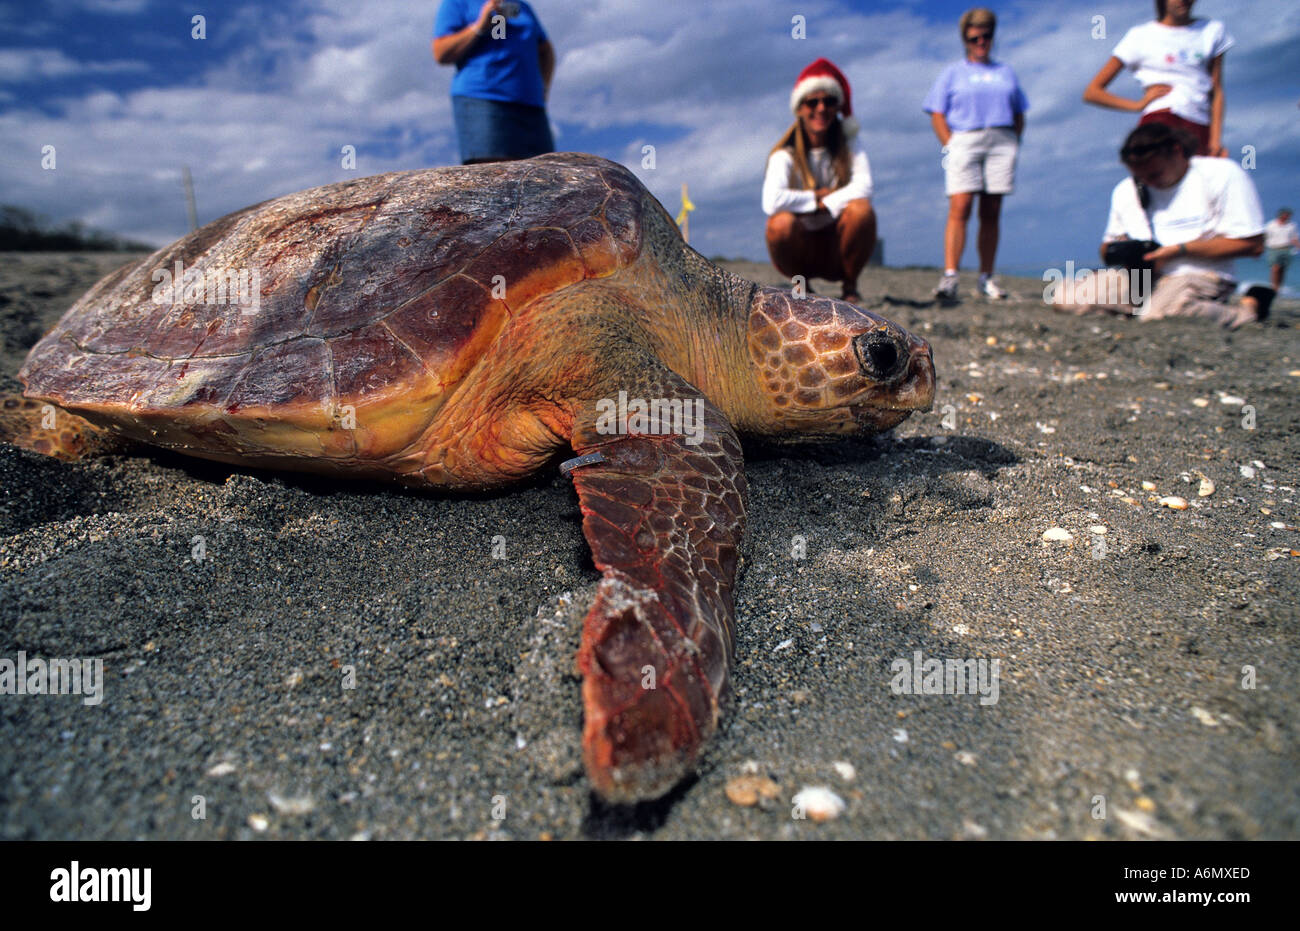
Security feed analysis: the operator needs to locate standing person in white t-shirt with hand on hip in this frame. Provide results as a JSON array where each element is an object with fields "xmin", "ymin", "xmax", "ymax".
[{"xmin": 1083, "ymin": 0, "xmax": 1232, "ymax": 156}]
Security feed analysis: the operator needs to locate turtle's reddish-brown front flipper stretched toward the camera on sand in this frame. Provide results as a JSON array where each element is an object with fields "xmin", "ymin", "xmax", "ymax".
[{"xmin": 566, "ymin": 373, "xmax": 746, "ymax": 802}]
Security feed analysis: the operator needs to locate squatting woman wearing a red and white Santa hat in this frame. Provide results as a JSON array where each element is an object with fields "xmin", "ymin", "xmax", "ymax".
[{"xmin": 763, "ymin": 59, "xmax": 876, "ymax": 304}]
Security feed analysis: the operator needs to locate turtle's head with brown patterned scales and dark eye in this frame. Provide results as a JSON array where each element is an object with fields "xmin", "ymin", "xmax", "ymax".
[{"xmin": 748, "ymin": 287, "xmax": 935, "ymax": 436}]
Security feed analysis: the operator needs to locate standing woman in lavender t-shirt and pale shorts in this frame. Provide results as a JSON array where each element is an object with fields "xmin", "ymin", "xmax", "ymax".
[{"xmin": 923, "ymin": 8, "xmax": 1030, "ymax": 300}]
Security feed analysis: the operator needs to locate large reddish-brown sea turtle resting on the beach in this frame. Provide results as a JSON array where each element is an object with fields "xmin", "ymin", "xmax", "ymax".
[{"xmin": 7, "ymin": 153, "xmax": 935, "ymax": 802}]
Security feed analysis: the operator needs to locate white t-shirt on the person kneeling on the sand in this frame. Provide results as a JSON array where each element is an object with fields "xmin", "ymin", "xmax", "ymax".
[{"xmin": 1102, "ymin": 156, "xmax": 1264, "ymax": 278}]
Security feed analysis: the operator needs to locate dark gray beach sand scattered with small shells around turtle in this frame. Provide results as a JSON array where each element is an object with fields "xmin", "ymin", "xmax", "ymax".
[{"xmin": 0, "ymin": 254, "xmax": 1300, "ymax": 839}]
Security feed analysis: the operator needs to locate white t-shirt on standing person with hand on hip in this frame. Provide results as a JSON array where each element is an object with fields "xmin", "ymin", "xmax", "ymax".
[{"xmin": 1112, "ymin": 20, "xmax": 1234, "ymax": 126}]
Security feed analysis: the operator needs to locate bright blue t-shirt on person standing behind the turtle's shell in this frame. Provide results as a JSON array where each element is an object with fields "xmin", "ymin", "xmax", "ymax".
[{"xmin": 433, "ymin": 0, "xmax": 547, "ymax": 107}]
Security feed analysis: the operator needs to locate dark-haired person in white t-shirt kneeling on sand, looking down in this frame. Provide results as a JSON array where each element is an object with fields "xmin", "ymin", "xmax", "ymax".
[{"xmin": 1058, "ymin": 124, "xmax": 1273, "ymax": 329}]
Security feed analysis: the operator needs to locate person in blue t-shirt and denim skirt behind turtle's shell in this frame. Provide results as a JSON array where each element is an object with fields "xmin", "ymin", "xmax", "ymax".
[{"xmin": 433, "ymin": 0, "xmax": 555, "ymax": 165}]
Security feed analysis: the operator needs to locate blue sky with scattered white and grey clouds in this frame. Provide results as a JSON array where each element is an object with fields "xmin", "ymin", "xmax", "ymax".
[{"xmin": 0, "ymin": 0, "xmax": 1300, "ymax": 270}]
